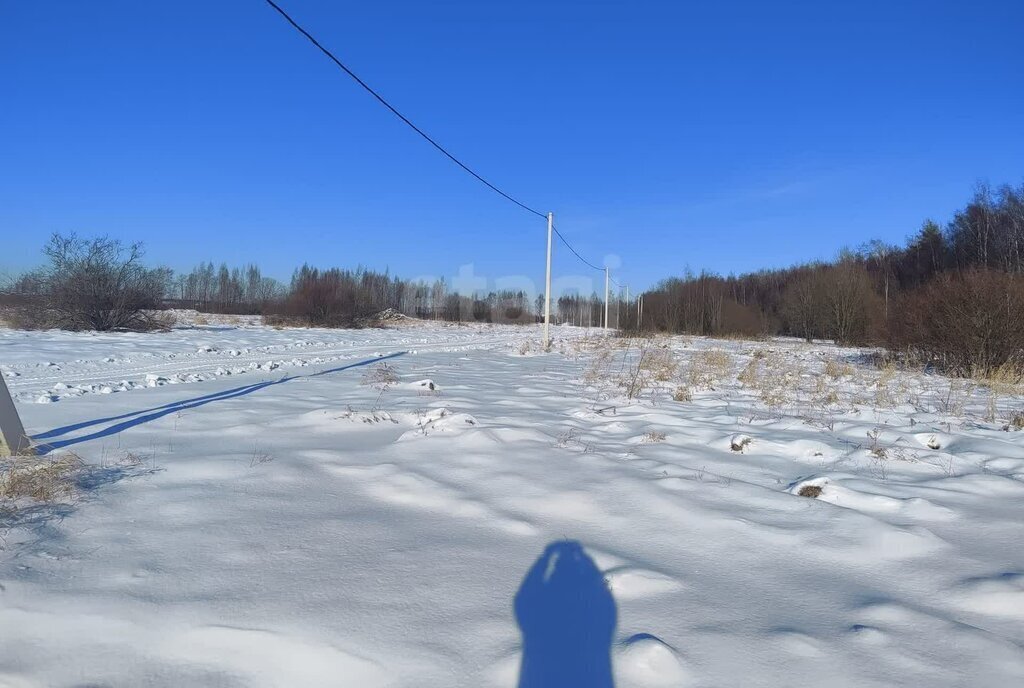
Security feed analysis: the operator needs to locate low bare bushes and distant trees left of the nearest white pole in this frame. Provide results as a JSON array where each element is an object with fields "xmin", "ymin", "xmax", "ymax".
[{"xmin": 0, "ymin": 233, "xmax": 543, "ymax": 331}]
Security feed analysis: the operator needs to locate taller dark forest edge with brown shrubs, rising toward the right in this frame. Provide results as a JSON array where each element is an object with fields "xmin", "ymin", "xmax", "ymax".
[{"xmin": 623, "ymin": 185, "xmax": 1024, "ymax": 375}]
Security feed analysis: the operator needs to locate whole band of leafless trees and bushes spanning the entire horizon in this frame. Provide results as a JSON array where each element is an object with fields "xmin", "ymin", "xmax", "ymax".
[{"xmin": 0, "ymin": 185, "xmax": 1024, "ymax": 375}]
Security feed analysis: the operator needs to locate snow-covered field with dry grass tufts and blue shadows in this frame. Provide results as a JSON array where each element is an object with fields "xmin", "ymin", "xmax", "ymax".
[{"xmin": 0, "ymin": 320, "xmax": 1024, "ymax": 688}]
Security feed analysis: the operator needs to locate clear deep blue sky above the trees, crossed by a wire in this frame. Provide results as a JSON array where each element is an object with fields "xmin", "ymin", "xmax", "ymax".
[{"xmin": 0, "ymin": 0, "xmax": 1024, "ymax": 289}]
